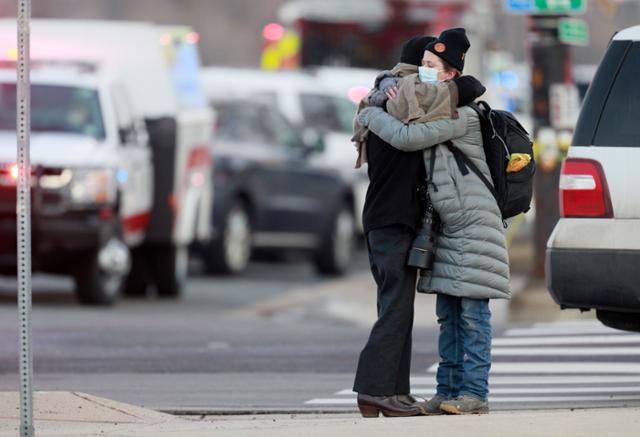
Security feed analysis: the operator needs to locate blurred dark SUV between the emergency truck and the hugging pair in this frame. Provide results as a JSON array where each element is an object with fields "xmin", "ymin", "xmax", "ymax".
[{"xmin": 196, "ymin": 98, "xmax": 355, "ymax": 275}]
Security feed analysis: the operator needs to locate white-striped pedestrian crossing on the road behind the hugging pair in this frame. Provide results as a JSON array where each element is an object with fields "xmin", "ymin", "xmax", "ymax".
[{"xmin": 305, "ymin": 320, "xmax": 640, "ymax": 410}]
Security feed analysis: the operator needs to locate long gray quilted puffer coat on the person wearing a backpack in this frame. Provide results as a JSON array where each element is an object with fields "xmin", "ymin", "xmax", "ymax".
[{"xmin": 359, "ymin": 107, "xmax": 511, "ymax": 299}]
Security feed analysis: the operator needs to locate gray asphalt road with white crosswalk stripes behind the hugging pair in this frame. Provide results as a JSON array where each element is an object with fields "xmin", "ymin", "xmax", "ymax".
[{"xmin": 0, "ymin": 253, "xmax": 640, "ymax": 413}]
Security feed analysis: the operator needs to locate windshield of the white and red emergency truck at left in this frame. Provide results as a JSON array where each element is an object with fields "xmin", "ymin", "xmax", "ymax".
[{"xmin": 0, "ymin": 83, "xmax": 105, "ymax": 139}]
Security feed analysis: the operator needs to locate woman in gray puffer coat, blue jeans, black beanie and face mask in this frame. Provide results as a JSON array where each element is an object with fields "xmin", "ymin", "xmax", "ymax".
[{"xmin": 358, "ymin": 29, "xmax": 510, "ymax": 414}]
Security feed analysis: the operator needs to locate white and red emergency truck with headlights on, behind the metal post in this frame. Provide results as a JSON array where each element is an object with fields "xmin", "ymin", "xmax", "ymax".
[{"xmin": 0, "ymin": 20, "xmax": 214, "ymax": 304}]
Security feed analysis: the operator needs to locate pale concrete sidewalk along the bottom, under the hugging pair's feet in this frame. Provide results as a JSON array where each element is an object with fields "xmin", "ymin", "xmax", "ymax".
[{"xmin": 0, "ymin": 392, "xmax": 640, "ymax": 437}]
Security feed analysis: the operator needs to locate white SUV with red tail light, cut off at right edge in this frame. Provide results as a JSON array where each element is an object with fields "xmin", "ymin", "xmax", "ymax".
[{"xmin": 546, "ymin": 26, "xmax": 640, "ymax": 331}]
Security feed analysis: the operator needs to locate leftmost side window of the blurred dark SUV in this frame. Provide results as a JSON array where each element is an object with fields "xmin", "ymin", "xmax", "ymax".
[{"xmin": 216, "ymin": 105, "xmax": 271, "ymax": 144}]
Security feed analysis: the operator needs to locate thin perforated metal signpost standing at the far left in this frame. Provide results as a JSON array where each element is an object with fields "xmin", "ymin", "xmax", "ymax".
[{"xmin": 16, "ymin": 0, "xmax": 35, "ymax": 437}]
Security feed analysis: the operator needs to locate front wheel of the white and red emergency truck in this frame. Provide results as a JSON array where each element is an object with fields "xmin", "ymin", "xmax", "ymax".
[{"xmin": 73, "ymin": 253, "xmax": 126, "ymax": 306}]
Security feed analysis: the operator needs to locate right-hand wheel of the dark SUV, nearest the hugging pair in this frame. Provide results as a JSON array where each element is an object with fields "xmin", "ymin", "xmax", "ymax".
[{"xmin": 315, "ymin": 203, "xmax": 356, "ymax": 276}]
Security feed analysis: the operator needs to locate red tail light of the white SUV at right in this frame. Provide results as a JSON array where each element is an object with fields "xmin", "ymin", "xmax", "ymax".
[{"xmin": 560, "ymin": 158, "xmax": 613, "ymax": 218}]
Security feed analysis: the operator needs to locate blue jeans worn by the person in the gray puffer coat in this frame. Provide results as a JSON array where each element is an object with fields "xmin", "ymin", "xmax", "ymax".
[{"xmin": 436, "ymin": 294, "xmax": 491, "ymax": 400}]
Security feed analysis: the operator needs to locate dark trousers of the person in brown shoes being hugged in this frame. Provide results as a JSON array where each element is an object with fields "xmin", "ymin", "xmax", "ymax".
[{"xmin": 353, "ymin": 225, "xmax": 416, "ymax": 396}]
